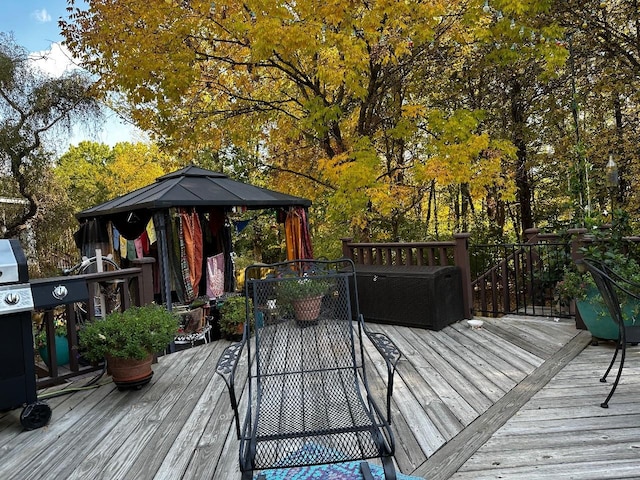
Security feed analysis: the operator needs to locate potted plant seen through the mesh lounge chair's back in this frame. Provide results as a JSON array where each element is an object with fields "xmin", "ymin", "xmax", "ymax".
[{"xmin": 276, "ymin": 275, "xmax": 330, "ymax": 326}]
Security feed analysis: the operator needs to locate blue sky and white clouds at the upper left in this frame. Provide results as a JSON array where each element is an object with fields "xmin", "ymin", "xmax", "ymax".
[{"xmin": 0, "ymin": 0, "xmax": 145, "ymax": 151}]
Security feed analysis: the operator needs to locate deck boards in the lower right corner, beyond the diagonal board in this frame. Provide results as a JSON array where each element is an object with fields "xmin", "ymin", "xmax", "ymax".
[{"xmin": 451, "ymin": 336, "xmax": 640, "ymax": 480}]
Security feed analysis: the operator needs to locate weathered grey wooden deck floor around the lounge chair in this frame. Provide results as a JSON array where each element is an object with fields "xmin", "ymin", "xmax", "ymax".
[{"xmin": 0, "ymin": 317, "xmax": 640, "ymax": 480}]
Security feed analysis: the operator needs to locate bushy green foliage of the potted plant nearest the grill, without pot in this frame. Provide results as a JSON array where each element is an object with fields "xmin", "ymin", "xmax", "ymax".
[{"xmin": 80, "ymin": 304, "xmax": 179, "ymax": 361}]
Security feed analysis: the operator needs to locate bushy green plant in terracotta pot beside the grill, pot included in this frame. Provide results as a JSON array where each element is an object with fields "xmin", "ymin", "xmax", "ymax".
[{"xmin": 80, "ymin": 304, "xmax": 178, "ymax": 389}]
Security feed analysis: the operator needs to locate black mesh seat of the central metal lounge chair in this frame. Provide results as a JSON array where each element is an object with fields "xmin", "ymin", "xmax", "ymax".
[{"xmin": 255, "ymin": 352, "xmax": 381, "ymax": 468}]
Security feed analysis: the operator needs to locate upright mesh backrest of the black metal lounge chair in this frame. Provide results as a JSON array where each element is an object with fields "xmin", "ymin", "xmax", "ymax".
[{"xmin": 245, "ymin": 260, "xmax": 364, "ymax": 379}]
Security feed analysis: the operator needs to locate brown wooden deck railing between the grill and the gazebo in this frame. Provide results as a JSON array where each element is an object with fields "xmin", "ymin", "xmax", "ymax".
[{"xmin": 31, "ymin": 258, "xmax": 154, "ymax": 388}]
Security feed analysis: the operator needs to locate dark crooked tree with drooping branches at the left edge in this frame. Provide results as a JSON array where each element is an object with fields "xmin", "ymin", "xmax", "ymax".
[{"xmin": 0, "ymin": 34, "xmax": 99, "ymax": 238}]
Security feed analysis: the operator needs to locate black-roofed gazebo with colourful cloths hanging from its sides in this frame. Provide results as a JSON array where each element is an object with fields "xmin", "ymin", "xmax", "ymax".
[{"xmin": 76, "ymin": 166, "xmax": 313, "ymax": 308}]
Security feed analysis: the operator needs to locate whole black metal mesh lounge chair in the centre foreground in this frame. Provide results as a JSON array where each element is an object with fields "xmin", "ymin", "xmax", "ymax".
[{"xmin": 217, "ymin": 260, "xmax": 401, "ymax": 480}]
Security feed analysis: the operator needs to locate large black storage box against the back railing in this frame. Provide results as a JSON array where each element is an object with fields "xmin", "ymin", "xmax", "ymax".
[{"xmin": 356, "ymin": 265, "xmax": 464, "ymax": 330}]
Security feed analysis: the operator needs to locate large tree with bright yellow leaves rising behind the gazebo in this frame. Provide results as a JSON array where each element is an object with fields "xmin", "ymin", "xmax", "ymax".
[{"xmin": 63, "ymin": 0, "xmax": 544, "ymax": 244}]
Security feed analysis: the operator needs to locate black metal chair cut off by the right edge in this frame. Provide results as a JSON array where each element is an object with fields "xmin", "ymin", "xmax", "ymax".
[{"xmin": 576, "ymin": 259, "xmax": 640, "ymax": 408}]
